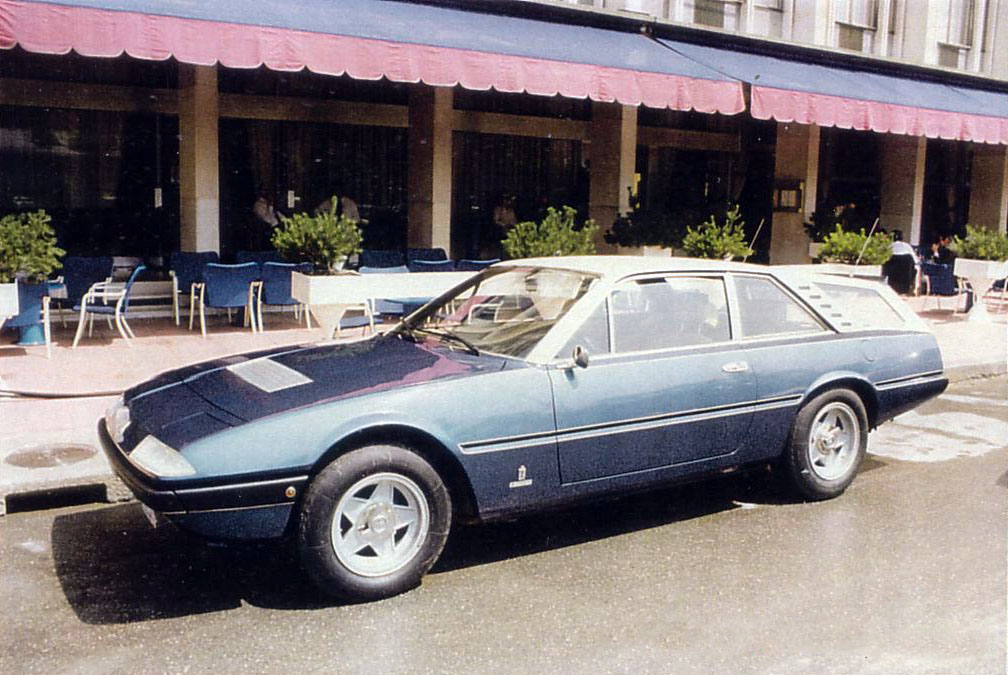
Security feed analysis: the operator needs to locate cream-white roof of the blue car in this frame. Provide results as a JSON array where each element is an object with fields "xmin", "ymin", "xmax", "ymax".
[{"xmin": 495, "ymin": 255, "xmax": 772, "ymax": 280}]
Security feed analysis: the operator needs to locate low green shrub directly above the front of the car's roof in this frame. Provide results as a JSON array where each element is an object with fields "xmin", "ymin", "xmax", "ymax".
[{"xmin": 501, "ymin": 207, "xmax": 599, "ymax": 258}]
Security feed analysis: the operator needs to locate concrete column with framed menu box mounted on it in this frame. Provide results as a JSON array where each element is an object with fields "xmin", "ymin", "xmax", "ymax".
[{"xmin": 770, "ymin": 123, "xmax": 820, "ymax": 265}]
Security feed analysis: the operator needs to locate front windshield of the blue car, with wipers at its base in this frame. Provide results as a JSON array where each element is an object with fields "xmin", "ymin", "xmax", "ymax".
[{"xmin": 398, "ymin": 267, "xmax": 597, "ymax": 358}]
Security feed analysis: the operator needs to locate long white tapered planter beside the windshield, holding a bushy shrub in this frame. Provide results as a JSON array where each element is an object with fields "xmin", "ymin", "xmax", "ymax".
[{"xmin": 290, "ymin": 272, "xmax": 476, "ymax": 336}]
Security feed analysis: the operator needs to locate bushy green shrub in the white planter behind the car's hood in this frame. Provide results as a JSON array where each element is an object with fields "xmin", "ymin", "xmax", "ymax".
[{"xmin": 271, "ymin": 195, "xmax": 364, "ymax": 274}]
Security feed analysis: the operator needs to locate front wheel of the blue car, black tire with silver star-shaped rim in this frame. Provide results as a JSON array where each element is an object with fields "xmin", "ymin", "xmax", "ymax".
[{"xmin": 297, "ymin": 445, "xmax": 452, "ymax": 601}]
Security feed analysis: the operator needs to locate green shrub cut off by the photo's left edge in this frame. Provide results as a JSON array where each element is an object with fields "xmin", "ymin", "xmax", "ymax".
[{"xmin": 0, "ymin": 209, "xmax": 67, "ymax": 283}]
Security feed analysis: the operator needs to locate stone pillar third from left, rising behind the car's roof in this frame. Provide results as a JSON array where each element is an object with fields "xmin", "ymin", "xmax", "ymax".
[{"xmin": 588, "ymin": 103, "xmax": 637, "ymax": 252}]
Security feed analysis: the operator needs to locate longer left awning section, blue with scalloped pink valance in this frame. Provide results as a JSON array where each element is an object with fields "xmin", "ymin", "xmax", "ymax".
[{"xmin": 0, "ymin": 0, "xmax": 745, "ymax": 114}]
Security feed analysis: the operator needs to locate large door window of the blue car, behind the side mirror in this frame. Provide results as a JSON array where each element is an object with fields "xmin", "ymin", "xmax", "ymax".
[{"xmin": 611, "ymin": 277, "xmax": 732, "ymax": 353}]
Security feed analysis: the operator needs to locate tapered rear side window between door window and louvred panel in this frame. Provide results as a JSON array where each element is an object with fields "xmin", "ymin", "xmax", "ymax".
[{"xmin": 735, "ymin": 276, "xmax": 825, "ymax": 338}]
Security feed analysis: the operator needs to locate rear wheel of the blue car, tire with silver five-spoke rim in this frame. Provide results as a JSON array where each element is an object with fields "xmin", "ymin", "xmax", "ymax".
[{"xmin": 782, "ymin": 389, "xmax": 868, "ymax": 501}]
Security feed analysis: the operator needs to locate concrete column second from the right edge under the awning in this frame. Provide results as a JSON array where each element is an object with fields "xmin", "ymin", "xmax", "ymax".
[{"xmin": 879, "ymin": 134, "xmax": 927, "ymax": 244}]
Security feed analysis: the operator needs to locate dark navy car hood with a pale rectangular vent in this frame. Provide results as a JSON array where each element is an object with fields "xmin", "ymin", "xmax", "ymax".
[{"xmin": 124, "ymin": 335, "xmax": 505, "ymax": 440}]
